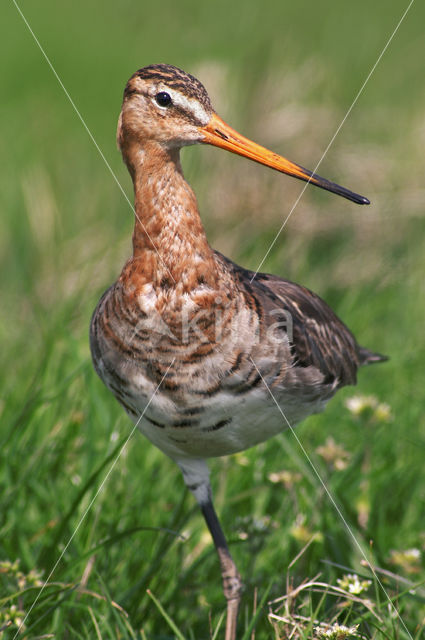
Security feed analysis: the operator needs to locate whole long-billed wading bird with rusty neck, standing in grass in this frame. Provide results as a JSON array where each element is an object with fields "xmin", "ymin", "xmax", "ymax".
[{"xmin": 90, "ymin": 64, "xmax": 386, "ymax": 640}]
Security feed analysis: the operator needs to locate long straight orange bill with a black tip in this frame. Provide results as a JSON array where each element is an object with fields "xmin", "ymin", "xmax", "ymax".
[{"xmin": 200, "ymin": 113, "xmax": 370, "ymax": 204}]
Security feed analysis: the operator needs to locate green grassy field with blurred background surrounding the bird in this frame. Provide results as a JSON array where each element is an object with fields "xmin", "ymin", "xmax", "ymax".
[{"xmin": 0, "ymin": 0, "xmax": 425, "ymax": 640}]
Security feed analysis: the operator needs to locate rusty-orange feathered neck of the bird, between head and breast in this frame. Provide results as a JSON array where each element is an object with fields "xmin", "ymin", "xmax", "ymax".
[{"xmin": 127, "ymin": 142, "xmax": 213, "ymax": 288}]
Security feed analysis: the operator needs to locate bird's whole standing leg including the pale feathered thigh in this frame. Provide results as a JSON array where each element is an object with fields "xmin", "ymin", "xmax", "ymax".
[{"xmin": 177, "ymin": 459, "xmax": 242, "ymax": 640}]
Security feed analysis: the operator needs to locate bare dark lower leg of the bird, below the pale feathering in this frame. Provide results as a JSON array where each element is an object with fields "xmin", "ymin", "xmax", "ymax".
[{"xmin": 200, "ymin": 498, "xmax": 242, "ymax": 640}]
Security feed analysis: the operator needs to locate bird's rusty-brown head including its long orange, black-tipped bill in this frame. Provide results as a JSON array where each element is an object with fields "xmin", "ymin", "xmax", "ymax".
[{"xmin": 117, "ymin": 64, "xmax": 369, "ymax": 204}]
